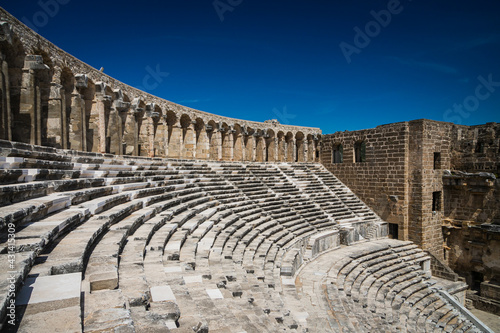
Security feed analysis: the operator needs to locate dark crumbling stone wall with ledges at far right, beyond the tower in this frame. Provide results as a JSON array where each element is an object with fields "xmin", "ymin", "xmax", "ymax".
[{"xmin": 443, "ymin": 123, "xmax": 500, "ymax": 294}]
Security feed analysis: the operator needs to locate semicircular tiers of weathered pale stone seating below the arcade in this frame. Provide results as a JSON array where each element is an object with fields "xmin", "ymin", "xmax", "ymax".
[{"xmin": 0, "ymin": 141, "xmax": 480, "ymax": 332}]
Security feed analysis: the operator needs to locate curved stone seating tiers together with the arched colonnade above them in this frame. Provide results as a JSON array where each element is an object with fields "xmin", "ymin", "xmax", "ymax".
[{"xmin": 0, "ymin": 5, "xmax": 492, "ymax": 332}]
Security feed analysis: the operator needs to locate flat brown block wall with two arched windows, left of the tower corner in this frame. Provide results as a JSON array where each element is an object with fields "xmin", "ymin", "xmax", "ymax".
[{"xmin": 321, "ymin": 123, "xmax": 409, "ymax": 239}]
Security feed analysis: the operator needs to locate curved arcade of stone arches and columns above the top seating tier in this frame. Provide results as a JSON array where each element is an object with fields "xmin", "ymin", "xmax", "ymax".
[{"xmin": 0, "ymin": 8, "xmax": 321, "ymax": 162}]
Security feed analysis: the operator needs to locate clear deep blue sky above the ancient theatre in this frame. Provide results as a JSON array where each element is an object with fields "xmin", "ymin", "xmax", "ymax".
[{"xmin": 0, "ymin": 0, "xmax": 500, "ymax": 133}]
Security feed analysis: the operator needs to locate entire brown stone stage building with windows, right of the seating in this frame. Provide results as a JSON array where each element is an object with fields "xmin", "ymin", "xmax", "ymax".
[{"xmin": 321, "ymin": 120, "xmax": 500, "ymax": 304}]
